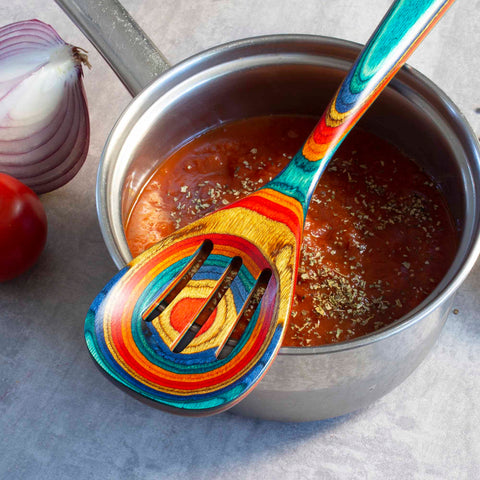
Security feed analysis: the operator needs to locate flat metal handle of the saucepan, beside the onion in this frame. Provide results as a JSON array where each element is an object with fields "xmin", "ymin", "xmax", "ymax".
[{"xmin": 55, "ymin": 0, "xmax": 170, "ymax": 96}]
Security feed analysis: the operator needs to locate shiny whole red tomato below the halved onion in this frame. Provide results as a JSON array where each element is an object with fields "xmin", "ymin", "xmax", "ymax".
[{"xmin": 0, "ymin": 173, "xmax": 47, "ymax": 282}]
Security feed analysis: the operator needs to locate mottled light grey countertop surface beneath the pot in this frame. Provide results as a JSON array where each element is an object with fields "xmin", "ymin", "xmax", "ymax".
[{"xmin": 0, "ymin": 0, "xmax": 480, "ymax": 480}]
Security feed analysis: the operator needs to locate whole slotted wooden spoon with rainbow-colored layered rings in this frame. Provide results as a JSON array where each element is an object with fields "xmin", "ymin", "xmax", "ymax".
[{"xmin": 85, "ymin": 0, "xmax": 453, "ymax": 415}]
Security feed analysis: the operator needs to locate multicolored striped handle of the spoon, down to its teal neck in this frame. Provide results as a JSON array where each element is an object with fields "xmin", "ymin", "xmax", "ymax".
[{"xmin": 264, "ymin": 0, "xmax": 454, "ymax": 215}]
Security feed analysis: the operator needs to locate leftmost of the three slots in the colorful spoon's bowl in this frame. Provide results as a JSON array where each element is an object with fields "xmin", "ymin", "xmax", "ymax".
[{"xmin": 143, "ymin": 240, "xmax": 213, "ymax": 322}]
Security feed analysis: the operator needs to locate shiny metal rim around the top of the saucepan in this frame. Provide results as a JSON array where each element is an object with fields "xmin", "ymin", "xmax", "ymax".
[{"xmin": 96, "ymin": 34, "xmax": 480, "ymax": 356}]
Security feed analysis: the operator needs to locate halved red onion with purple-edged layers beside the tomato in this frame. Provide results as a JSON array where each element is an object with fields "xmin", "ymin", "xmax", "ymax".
[{"xmin": 0, "ymin": 20, "xmax": 90, "ymax": 193}]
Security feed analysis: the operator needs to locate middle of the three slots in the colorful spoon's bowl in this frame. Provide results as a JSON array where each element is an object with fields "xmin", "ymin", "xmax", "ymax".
[{"xmin": 173, "ymin": 256, "xmax": 243, "ymax": 353}]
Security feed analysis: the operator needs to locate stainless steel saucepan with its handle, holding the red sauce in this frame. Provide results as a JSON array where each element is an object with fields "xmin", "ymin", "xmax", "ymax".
[{"xmin": 58, "ymin": 0, "xmax": 480, "ymax": 421}]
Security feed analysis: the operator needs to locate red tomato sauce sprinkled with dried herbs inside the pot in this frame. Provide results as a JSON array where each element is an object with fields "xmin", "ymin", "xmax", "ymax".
[{"xmin": 125, "ymin": 116, "xmax": 457, "ymax": 346}]
